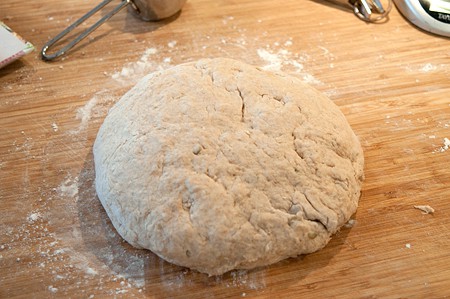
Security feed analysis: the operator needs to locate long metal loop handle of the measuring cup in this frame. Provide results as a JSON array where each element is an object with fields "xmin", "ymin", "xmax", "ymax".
[{"xmin": 41, "ymin": 0, "xmax": 131, "ymax": 61}]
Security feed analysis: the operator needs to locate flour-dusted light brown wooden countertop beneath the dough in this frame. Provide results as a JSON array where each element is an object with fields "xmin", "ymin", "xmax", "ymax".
[{"xmin": 0, "ymin": 0, "xmax": 450, "ymax": 298}]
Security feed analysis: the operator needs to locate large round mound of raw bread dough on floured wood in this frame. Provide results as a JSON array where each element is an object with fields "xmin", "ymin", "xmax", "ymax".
[{"xmin": 94, "ymin": 58, "xmax": 363, "ymax": 275}]
